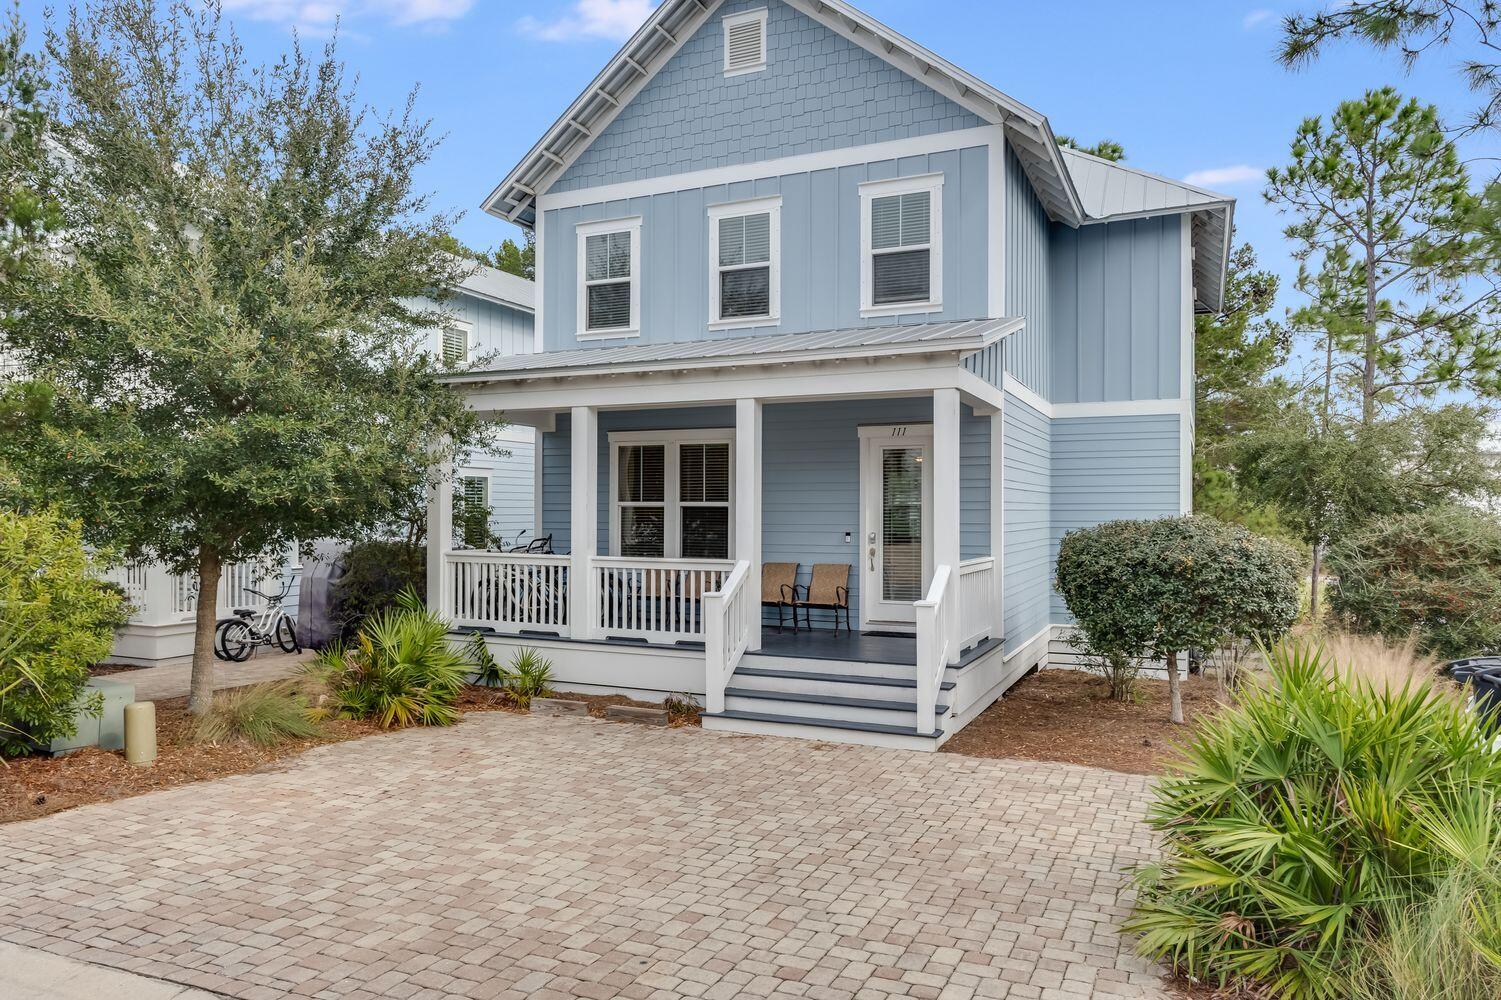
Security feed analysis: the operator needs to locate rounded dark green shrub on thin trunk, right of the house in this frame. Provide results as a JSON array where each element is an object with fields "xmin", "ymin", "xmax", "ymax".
[{"xmin": 1057, "ymin": 517, "xmax": 1300, "ymax": 722}]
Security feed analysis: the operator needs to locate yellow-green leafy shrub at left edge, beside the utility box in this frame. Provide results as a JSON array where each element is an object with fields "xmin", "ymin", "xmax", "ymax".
[{"xmin": 0, "ymin": 511, "xmax": 128, "ymax": 757}]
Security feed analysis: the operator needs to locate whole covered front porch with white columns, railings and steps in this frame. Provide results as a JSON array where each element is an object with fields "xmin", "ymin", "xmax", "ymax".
[{"xmin": 429, "ymin": 322, "xmax": 1026, "ymax": 737}]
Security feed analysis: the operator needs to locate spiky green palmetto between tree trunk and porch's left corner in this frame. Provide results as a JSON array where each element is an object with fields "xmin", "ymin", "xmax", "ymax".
[{"xmin": 311, "ymin": 592, "xmax": 471, "ymax": 730}]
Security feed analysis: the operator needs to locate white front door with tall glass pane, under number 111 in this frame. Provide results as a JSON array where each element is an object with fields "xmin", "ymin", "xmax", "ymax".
[{"xmin": 860, "ymin": 423, "xmax": 934, "ymax": 628}]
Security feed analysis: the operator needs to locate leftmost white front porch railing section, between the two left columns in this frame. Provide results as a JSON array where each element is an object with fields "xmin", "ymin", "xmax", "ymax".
[{"xmin": 444, "ymin": 551, "xmax": 569, "ymax": 635}]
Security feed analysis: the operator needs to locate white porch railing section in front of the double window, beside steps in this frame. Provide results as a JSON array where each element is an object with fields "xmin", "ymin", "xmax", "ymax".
[{"xmin": 590, "ymin": 557, "xmax": 735, "ymax": 643}]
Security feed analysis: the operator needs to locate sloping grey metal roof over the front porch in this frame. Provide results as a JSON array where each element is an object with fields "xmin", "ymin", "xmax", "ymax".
[{"xmin": 444, "ymin": 317, "xmax": 1027, "ymax": 384}]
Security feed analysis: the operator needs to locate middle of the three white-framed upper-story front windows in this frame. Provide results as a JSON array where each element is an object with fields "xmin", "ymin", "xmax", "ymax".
[{"xmin": 708, "ymin": 198, "xmax": 782, "ymax": 330}]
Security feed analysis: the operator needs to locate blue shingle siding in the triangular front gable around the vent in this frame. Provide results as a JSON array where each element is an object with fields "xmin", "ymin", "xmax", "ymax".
[{"xmin": 549, "ymin": 0, "xmax": 985, "ymax": 192}]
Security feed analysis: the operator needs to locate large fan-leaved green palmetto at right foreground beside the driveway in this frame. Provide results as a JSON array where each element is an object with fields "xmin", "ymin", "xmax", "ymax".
[{"xmin": 1127, "ymin": 646, "xmax": 1501, "ymax": 1000}]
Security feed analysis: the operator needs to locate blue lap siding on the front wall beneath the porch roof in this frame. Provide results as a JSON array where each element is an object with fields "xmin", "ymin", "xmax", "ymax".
[{"xmin": 542, "ymin": 396, "xmax": 991, "ymax": 628}]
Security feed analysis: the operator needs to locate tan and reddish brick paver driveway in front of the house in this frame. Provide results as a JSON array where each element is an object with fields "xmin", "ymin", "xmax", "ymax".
[{"xmin": 0, "ymin": 715, "xmax": 1163, "ymax": 1000}]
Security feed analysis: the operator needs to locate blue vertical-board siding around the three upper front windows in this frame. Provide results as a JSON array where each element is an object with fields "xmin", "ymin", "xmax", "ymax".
[{"xmin": 542, "ymin": 146, "xmax": 989, "ymax": 351}]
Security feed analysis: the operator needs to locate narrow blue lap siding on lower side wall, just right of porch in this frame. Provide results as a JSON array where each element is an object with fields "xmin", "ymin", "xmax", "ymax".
[{"xmin": 1003, "ymin": 393, "xmax": 1054, "ymax": 655}]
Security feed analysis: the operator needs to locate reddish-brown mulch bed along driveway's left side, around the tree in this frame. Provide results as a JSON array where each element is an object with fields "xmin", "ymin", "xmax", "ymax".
[{"xmin": 0, "ymin": 681, "xmax": 699, "ymax": 823}]
